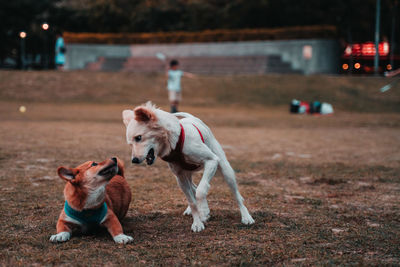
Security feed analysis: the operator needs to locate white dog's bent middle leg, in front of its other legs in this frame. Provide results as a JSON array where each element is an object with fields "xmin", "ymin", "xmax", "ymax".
[{"xmin": 196, "ymin": 156, "xmax": 218, "ymax": 222}]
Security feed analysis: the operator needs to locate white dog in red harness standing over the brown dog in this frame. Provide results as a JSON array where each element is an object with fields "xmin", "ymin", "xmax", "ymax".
[{"xmin": 122, "ymin": 102, "xmax": 254, "ymax": 232}]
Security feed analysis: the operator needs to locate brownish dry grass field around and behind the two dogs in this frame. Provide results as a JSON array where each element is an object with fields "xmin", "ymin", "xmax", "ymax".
[{"xmin": 0, "ymin": 71, "xmax": 400, "ymax": 266}]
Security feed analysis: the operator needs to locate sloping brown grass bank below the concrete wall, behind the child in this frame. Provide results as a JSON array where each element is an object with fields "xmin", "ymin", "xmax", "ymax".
[{"xmin": 0, "ymin": 71, "xmax": 400, "ymax": 112}]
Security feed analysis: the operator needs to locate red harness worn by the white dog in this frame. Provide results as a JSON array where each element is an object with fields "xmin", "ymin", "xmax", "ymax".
[{"xmin": 162, "ymin": 123, "xmax": 204, "ymax": 171}]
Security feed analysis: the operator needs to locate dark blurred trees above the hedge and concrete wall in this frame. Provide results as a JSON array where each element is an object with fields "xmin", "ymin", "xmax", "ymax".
[{"xmin": 0, "ymin": 0, "xmax": 400, "ymax": 66}]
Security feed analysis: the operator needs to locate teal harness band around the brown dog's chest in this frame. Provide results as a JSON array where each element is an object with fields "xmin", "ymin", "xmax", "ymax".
[{"xmin": 64, "ymin": 201, "xmax": 107, "ymax": 224}]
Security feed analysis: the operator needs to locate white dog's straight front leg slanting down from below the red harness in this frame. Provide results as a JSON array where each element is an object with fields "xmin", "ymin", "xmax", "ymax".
[{"xmin": 171, "ymin": 172, "xmax": 205, "ymax": 232}]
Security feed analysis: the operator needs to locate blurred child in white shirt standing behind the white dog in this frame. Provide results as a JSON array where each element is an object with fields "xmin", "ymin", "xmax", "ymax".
[{"xmin": 167, "ymin": 59, "xmax": 196, "ymax": 113}]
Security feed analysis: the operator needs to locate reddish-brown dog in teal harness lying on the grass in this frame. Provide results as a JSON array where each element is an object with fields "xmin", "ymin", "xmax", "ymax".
[{"xmin": 50, "ymin": 158, "xmax": 133, "ymax": 244}]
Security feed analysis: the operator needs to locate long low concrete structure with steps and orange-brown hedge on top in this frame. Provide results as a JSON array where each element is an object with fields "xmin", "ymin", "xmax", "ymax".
[{"xmin": 65, "ymin": 27, "xmax": 340, "ymax": 74}]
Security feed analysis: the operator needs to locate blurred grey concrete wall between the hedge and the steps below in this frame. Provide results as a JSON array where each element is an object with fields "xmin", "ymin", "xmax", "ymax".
[{"xmin": 66, "ymin": 39, "xmax": 339, "ymax": 74}]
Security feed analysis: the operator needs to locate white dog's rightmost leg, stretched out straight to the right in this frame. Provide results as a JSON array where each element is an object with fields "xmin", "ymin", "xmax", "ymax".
[{"xmin": 219, "ymin": 159, "xmax": 254, "ymax": 224}]
